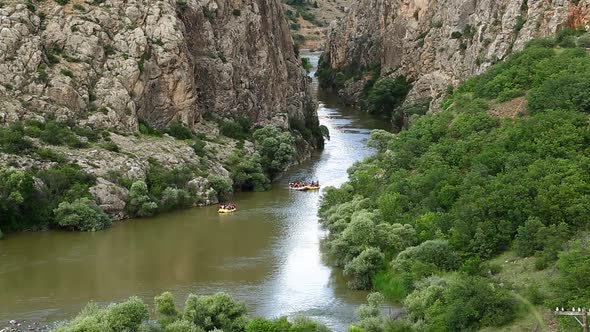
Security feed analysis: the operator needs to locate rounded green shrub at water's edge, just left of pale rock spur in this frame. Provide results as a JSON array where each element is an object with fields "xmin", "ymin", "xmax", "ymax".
[{"xmin": 53, "ymin": 197, "xmax": 111, "ymax": 232}]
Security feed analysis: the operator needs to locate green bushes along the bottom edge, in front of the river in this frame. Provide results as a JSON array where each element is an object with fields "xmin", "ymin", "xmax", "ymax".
[{"xmin": 56, "ymin": 292, "xmax": 330, "ymax": 332}]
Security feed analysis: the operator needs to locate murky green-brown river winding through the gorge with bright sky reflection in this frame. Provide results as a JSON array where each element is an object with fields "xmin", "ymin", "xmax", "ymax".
[{"xmin": 0, "ymin": 53, "xmax": 394, "ymax": 331}]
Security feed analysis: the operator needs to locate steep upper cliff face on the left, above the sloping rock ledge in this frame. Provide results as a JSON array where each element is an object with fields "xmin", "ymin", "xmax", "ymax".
[{"xmin": 0, "ymin": 0, "xmax": 317, "ymax": 132}]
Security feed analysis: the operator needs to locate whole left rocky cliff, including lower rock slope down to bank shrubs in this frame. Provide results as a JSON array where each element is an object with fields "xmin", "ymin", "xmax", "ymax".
[{"xmin": 0, "ymin": 0, "xmax": 322, "ymax": 224}]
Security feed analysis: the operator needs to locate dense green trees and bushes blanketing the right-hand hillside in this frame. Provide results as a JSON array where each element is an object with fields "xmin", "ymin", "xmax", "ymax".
[{"xmin": 320, "ymin": 38, "xmax": 590, "ymax": 331}]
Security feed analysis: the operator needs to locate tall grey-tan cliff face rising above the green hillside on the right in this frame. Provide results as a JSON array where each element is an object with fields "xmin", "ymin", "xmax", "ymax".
[{"xmin": 324, "ymin": 0, "xmax": 590, "ymax": 109}]
